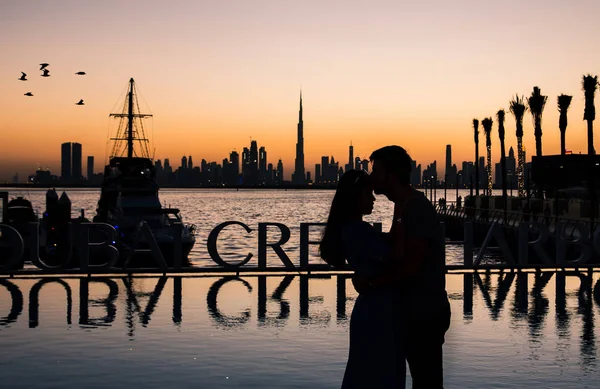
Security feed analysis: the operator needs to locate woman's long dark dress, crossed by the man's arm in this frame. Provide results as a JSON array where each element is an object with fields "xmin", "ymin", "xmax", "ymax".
[{"xmin": 342, "ymin": 222, "xmax": 406, "ymax": 389}]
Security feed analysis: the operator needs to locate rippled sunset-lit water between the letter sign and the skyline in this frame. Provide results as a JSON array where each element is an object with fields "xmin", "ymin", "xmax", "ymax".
[{"xmin": 7, "ymin": 188, "xmax": 469, "ymax": 266}]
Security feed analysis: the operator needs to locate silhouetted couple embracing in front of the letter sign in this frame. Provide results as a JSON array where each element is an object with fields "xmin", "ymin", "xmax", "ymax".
[{"xmin": 320, "ymin": 146, "xmax": 450, "ymax": 389}]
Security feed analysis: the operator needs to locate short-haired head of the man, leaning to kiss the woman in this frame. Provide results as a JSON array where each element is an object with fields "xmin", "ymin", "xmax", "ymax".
[{"xmin": 369, "ymin": 146, "xmax": 412, "ymax": 197}]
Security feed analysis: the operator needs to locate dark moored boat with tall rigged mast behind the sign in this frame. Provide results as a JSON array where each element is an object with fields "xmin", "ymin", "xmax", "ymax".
[{"xmin": 93, "ymin": 78, "xmax": 196, "ymax": 267}]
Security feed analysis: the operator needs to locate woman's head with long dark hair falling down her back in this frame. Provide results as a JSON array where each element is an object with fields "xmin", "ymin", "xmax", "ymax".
[{"xmin": 320, "ymin": 170, "xmax": 375, "ymax": 267}]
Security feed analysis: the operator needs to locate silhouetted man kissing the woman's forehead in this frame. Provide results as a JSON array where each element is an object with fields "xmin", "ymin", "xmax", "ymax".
[{"xmin": 353, "ymin": 146, "xmax": 450, "ymax": 389}]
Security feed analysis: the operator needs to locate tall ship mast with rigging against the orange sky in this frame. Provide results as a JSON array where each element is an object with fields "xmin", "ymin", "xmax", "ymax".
[{"xmin": 109, "ymin": 78, "xmax": 152, "ymax": 158}]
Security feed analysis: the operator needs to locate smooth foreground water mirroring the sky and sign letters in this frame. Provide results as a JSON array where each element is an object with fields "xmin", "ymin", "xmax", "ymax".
[{"xmin": 0, "ymin": 272, "xmax": 600, "ymax": 388}]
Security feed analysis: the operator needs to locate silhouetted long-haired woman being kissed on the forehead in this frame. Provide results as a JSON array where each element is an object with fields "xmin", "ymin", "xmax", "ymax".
[{"xmin": 320, "ymin": 170, "xmax": 406, "ymax": 389}]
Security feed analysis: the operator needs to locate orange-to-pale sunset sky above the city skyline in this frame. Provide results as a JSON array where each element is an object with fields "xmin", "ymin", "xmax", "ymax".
[{"xmin": 0, "ymin": 0, "xmax": 600, "ymax": 181}]
